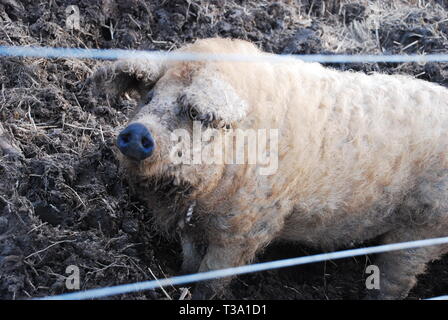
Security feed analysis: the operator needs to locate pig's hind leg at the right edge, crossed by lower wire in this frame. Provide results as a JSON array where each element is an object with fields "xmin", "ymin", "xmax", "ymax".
[{"xmin": 368, "ymin": 173, "xmax": 448, "ymax": 299}]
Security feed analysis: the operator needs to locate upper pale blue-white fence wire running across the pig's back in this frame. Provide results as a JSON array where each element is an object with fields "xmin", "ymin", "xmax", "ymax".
[{"xmin": 0, "ymin": 46, "xmax": 448, "ymax": 63}]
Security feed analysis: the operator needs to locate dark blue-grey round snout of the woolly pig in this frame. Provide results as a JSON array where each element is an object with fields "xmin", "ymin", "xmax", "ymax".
[{"xmin": 117, "ymin": 123, "xmax": 155, "ymax": 161}]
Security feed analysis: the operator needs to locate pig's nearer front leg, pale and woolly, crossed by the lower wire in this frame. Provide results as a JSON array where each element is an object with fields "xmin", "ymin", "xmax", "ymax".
[{"xmin": 193, "ymin": 214, "xmax": 283, "ymax": 299}]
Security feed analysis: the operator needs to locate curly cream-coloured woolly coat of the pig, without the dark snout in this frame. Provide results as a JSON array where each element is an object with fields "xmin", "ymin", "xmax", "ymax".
[{"xmin": 94, "ymin": 39, "xmax": 448, "ymax": 299}]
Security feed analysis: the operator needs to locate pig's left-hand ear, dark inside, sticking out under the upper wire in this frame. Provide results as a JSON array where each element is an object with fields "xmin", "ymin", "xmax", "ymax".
[{"xmin": 88, "ymin": 60, "xmax": 164, "ymax": 97}]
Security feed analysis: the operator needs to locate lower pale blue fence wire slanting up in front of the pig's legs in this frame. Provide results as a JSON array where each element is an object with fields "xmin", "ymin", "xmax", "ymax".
[{"xmin": 38, "ymin": 237, "xmax": 448, "ymax": 300}]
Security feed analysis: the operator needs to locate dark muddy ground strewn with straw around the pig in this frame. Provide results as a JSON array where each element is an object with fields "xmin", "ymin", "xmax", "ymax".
[{"xmin": 0, "ymin": 0, "xmax": 448, "ymax": 299}]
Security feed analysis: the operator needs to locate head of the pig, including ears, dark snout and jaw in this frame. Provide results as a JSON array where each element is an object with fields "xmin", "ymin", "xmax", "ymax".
[{"xmin": 90, "ymin": 40, "xmax": 270, "ymax": 231}]
